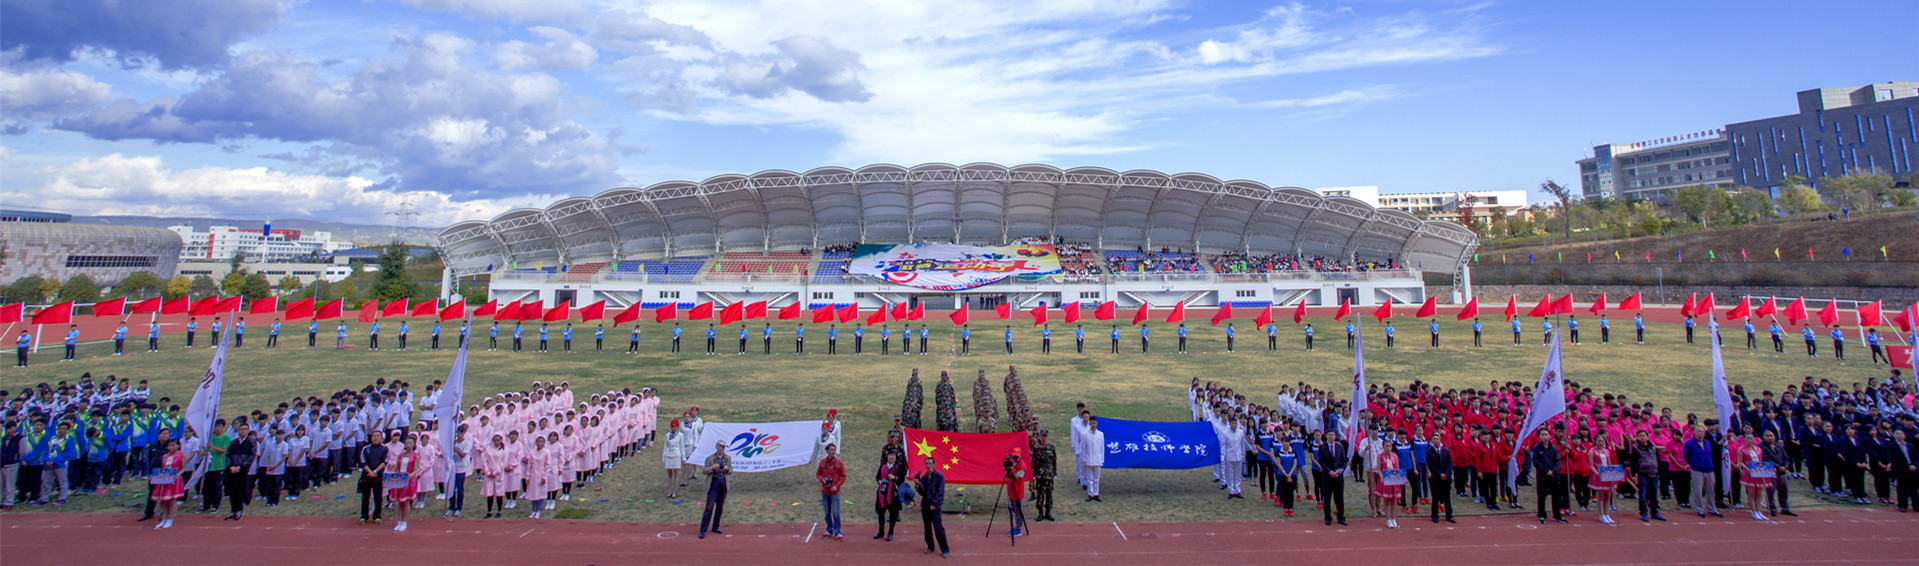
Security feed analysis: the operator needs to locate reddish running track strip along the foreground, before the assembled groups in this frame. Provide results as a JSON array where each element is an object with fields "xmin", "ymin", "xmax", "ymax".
[{"xmin": 0, "ymin": 507, "xmax": 1919, "ymax": 566}]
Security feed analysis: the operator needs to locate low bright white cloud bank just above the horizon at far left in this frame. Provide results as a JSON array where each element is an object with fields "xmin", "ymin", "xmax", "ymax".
[{"xmin": 13, "ymin": 153, "xmax": 507, "ymax": 226}]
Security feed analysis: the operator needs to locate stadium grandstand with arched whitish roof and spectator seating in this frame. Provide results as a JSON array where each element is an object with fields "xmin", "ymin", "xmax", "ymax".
[{"xmin": 439, "ymin": 163, "xmax": 1478, "ymax": 309}]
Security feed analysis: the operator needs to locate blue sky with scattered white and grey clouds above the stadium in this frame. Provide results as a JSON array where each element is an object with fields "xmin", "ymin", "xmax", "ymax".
[{"xmin": 0, "ymin": 0, "xmax": 1919, "ymax": 224}]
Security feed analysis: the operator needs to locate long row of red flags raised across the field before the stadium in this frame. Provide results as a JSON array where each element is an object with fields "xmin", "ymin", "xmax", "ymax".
[{"xmin": 0, "ymin": 294, "xmax": 1919, "ymax": 332}]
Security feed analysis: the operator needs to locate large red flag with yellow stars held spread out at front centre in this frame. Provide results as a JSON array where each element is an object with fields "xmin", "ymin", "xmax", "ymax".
[{"xmin": 906, "ymin": 428, "xmax": 1032, "ymax": 485}]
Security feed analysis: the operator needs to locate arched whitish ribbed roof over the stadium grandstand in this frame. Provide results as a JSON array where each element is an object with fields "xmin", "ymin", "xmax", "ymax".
[{"xmin": 439, "ymin": 163, "xmax": 1478, "ymax": 274}]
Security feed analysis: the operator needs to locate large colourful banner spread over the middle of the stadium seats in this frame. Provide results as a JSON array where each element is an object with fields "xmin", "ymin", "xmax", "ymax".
[{"xmin": 846, "ymin": 244, "xmax": 1059, "ymax": 292}]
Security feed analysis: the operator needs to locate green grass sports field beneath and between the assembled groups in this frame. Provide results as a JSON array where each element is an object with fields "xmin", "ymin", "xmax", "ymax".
[{"xmin": 0, "ymin": 318, "xmax": 1886, "ymax": 535}]
